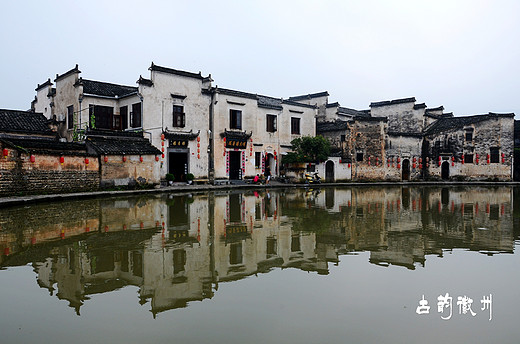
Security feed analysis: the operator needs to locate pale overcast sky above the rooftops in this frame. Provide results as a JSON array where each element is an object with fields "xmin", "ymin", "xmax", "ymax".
[{"xmin": 0, "ymin": 0, "xmax": 520, "ymax": 119}]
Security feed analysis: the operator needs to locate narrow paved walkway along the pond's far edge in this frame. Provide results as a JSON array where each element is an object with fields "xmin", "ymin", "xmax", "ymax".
[{"xmin": 0, "ymin": 181, "xmax": 520, "ymax": 208}]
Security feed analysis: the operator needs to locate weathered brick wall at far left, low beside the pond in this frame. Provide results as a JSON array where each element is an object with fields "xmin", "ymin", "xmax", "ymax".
[{"xmin": 0, "ymin": 147, "xmax": 100, "ymax": 196}]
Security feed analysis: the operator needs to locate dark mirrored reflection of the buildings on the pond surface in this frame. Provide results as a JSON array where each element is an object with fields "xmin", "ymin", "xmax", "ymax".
[{"xmin": 0, "ymin": 187, "xmax": 520, "ymax": 316}]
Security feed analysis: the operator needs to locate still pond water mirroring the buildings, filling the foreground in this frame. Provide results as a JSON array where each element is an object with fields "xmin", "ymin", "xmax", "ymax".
[{"xmin": 0, "ymin": 186, "xmax": 520, "ymax": 343}]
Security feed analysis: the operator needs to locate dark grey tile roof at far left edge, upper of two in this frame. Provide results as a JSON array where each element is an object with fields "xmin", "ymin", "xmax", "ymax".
[{"xmin": 0, "ymin": 109, "xmax": 54, "ymax": 135}]
